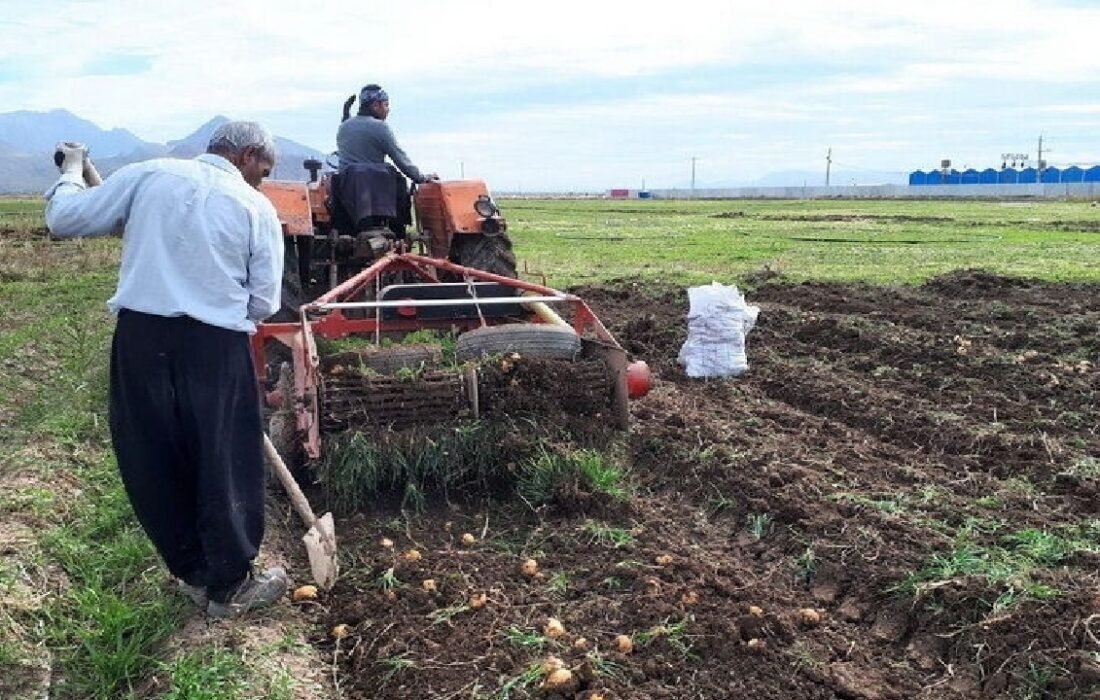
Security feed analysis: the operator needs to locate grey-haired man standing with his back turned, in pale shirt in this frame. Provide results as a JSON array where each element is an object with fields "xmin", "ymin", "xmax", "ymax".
[{"xmin": 45, "ymin": 121, "xmax": 288, "ymax": 617}]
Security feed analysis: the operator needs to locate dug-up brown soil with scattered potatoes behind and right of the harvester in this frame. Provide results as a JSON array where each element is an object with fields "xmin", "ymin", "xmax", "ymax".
[{"xmin": 288, "ymin": 271, "xmax": 1100, "ymax": 700}]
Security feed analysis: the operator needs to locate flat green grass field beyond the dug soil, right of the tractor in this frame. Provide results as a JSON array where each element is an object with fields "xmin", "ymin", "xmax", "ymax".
[{"xmin": 502, "ymin": 200, "xmax": 1100, "ymax": 285}]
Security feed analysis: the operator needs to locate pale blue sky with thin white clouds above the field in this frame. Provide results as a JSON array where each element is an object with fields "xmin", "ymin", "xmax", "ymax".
[{"xmin": 0, "ymin": 0, "xmax": 1100, "ymax": 192}]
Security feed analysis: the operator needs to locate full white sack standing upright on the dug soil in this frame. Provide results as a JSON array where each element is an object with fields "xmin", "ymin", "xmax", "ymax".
[{"xmin": 678, "ymin": 282, "xmax": 760, "ymax": 376}]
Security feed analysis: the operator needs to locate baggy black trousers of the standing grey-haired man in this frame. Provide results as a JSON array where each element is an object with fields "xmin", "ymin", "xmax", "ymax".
[{"xmin": 110, "ymin": 310, "xmax": 264, "ymax": 601}]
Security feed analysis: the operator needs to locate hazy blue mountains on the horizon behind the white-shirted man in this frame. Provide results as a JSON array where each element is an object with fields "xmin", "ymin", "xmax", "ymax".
[{"xmin": 0, "ymin": 109, "xmax": 325, "ymax": 194}]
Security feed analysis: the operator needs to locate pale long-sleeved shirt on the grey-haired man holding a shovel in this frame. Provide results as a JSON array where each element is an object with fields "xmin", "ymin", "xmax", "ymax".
[{"xmin": 46, "ymin": 153, "xmax": 283, "ymax": 333}]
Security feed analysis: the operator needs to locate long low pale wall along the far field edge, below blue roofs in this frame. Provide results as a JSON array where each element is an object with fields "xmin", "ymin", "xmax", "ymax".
[{"xmin": 627, "ymin": 183, "xmax": 1100, "ymax": 199}]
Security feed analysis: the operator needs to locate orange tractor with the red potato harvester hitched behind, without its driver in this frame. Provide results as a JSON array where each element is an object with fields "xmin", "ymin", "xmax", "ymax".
[{"xmin": 252, "ymin": 169, "xmax": 650, "ymax": 459}]
